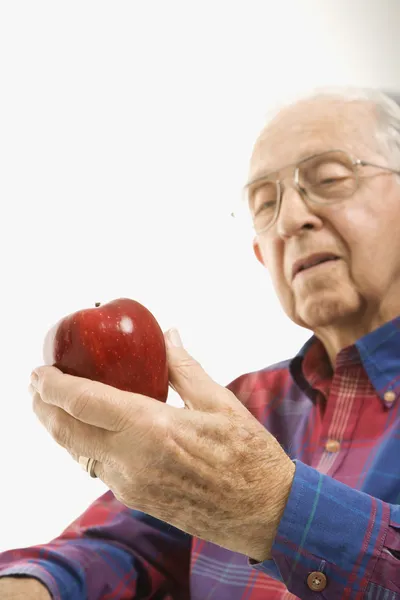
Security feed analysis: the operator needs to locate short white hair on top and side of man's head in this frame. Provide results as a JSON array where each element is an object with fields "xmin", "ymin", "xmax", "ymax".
[{"xmin": 270, "ymin": 86, "xmax": 400, "ymax": 169}]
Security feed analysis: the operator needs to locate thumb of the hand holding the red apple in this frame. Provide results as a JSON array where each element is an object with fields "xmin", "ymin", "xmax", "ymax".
[{"xmin": 164, "ymin": 329, "xmax": 234, "ymax": 412}]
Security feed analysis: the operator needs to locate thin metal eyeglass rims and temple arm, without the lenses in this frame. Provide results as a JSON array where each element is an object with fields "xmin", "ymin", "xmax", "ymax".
[{"xmin": 236, "ymin": 149, "xmax": 400, "ymax": 235}]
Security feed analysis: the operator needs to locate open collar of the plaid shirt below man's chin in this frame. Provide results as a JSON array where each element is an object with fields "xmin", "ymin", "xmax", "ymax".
[{"xmin": 289, "ymin": 317, "xmax": 400, "ymax": 407}]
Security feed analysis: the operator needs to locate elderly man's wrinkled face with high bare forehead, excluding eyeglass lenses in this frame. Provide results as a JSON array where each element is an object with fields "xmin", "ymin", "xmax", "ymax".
[{"xmin": 250, "ymin": 99, "xmax": 400, "ymax": 331}]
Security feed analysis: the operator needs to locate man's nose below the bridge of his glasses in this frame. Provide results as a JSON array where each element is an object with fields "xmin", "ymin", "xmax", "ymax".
[{"xmin": 276, "ymin": 185, "xmax": 322, "ymax": 239}]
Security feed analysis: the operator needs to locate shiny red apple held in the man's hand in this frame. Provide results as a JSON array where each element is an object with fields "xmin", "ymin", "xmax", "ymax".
[{"xmin": 43, "ymin": 298, "xmax": 168, "ymax": 402}]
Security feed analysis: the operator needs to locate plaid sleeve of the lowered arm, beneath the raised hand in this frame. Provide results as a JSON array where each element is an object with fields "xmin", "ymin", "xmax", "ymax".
[{"xmin": 0, "ymin": 492, "xmax": 191, "ymax": 600}]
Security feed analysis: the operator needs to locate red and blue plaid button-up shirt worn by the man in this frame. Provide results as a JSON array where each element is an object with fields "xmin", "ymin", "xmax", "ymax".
[{"xmin": 0, "ymin": 318, "xmax": 400, "ymax": 600}]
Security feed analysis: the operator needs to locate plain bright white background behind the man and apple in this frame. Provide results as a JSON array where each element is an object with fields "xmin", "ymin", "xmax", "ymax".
[{"xmin": 0, "ymin": 0, "xmax": 400, "ymax": 550}]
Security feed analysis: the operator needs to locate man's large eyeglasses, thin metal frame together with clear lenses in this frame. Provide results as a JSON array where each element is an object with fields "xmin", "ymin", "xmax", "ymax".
[{"xmin": 232, "ymin": 150, "xmax": 400, "ymax": 234}]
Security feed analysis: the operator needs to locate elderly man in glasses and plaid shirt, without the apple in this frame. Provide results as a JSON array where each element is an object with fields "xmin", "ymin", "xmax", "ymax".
[{"xmin": 0, "ymin": 85, "xmax": 400, "ymax": 600}]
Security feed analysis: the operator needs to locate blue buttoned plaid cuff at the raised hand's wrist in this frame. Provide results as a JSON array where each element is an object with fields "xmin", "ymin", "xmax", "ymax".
[{"xmin": 248, "ymin": 460, "xmax": 390, "ymax": 598}]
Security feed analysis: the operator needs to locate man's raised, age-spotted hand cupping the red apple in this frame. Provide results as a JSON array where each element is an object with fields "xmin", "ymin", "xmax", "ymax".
[{"xmin": 31, "ymin": 332, "xmax": 295, "ymax": 561}]
